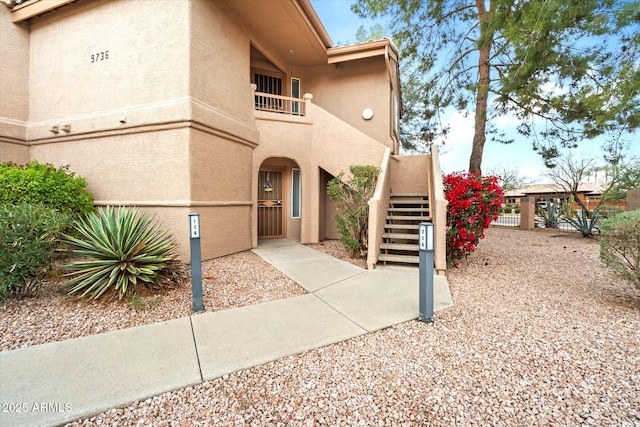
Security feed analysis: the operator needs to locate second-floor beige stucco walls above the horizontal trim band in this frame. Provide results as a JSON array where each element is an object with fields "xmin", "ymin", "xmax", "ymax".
[{"xmin": 0, "ymin": 0, "xmax": 398, "ymax": 154}]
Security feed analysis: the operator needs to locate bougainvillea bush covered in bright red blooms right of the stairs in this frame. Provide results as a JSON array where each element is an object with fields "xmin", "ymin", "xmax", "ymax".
[{"xmin": 444, "ymin": 172, "xmax": 504, "ymax": 264}]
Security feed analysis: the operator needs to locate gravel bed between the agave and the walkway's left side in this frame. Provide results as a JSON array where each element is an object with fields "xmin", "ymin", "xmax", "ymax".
[{"xmin": 0, "ymin": 251, "xmax": 306, "ymax": 350}]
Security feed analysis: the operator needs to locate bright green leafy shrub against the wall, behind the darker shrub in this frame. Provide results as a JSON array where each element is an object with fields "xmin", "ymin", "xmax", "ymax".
[{"xmin": 0, "ymin": 161, "xmax": 93, "ymax": 219}]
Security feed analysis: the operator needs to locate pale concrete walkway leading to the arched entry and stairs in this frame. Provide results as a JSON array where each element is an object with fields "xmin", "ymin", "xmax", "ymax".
[{"xmin": 0, "ymin": 239, "xmax": 453, "ymax": 426}]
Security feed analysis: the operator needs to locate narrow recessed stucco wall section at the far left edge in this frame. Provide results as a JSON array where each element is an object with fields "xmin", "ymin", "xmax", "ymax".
[{"xmin": 0, "ymin": 7, "xmax": 29, "ymax": 163}]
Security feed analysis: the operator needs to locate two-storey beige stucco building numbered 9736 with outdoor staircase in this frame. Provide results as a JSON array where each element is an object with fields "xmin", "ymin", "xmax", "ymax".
[{"xmin": 0, "ymin": 0, "xmax": 445, "ymax": 272}]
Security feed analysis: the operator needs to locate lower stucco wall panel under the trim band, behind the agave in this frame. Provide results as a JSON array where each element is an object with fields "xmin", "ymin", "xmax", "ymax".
[{"xmin": 32, "ymin": 128, "xmax": 190, "ymax": 204}]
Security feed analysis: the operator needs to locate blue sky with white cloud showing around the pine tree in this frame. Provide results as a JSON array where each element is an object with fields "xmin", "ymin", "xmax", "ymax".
[{"xmin": 311, "ymin": 0, "xmax": 640, "ymax": 182}]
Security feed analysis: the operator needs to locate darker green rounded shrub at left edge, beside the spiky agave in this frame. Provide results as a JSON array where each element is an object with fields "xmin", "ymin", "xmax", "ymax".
[{"xmin": 0, "ymin": 204, "xmax": 71, "ymax": 301}]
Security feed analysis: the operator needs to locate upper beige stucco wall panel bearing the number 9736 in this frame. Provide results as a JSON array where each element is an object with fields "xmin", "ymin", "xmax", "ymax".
[{"xmin": 29, "ymin": 0, "xmax": 189, "ymax": 122}]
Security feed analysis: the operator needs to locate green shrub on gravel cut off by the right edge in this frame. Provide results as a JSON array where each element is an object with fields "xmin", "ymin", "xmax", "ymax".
[{"xmin": 600, "ymin": 210, "xmax": 640, "ymax": 289}]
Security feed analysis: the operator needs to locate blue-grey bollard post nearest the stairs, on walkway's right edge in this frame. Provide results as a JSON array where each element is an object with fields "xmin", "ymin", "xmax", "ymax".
[{"xmin": 418, "ymin": 222, "xmax": 433, "ymax": 323}]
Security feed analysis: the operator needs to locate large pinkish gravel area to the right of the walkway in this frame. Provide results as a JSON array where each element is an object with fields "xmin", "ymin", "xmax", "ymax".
[{"xmin": 2, "ymin": 228, "xmax": 640, "ymax": 426}]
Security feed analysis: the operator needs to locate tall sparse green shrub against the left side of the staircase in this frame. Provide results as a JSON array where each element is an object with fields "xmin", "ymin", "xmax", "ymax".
[{"xmin": 327, "ymin": 166, "xmax": 380, "ymax": 257}]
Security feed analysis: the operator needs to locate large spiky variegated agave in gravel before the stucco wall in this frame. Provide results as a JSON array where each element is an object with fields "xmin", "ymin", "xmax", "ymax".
[{"xmin": 65, "ymin": 206, "xmax": 183, "ymax": 299}]
